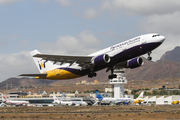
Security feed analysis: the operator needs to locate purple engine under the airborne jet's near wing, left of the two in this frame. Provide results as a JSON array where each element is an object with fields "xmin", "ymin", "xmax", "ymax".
[{"xmin": 91, "ymin": 54, "xmax": 111, "ymax": 66}]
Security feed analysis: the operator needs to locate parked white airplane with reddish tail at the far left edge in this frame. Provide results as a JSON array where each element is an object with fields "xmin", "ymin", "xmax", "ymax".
[{"xmin": 1, "ymin": 94, "xmax": 30, "ymax": 106}]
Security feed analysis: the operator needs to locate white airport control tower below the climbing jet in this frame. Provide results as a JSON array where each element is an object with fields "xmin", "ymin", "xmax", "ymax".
[{"xmin": 110, "ymin": 69, "xmax": 127, "ymax": 98}]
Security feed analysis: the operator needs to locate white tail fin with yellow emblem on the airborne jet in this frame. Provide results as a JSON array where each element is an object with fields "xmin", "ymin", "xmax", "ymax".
[{"xmin": 30, "ymin": 50, "xmax": 57, "ymax": 73}]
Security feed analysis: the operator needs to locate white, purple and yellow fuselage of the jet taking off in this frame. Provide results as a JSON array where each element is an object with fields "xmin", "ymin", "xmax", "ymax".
[{"xmin": 36, "ymin": 34, "xmax": 165, "ymax": 80}]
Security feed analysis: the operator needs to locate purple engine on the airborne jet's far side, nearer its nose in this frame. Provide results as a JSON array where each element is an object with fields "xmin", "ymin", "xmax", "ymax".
[{"xmin": 126, "ymin": 57, "xmax": 144, "ymax": 69}]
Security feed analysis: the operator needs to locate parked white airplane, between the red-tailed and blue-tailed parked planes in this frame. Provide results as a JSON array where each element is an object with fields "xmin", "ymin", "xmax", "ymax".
[{"xmin": 53, "ymin": 96, "xmax": 88, "ymax": 106}]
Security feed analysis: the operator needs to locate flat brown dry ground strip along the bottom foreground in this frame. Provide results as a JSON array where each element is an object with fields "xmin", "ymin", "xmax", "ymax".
[{"xmin": 0, "ymin": 105, "xmax": 180, "ymax": 120}]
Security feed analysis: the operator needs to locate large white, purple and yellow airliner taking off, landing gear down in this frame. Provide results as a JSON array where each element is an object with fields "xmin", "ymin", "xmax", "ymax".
[{"xmin": 20, "ymin": 34, "xmax": 165, "ymax": 80}]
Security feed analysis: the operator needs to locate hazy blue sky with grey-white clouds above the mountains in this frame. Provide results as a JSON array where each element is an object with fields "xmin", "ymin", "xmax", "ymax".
[{"xmin": 0, "ymin": 0, "xmax": 180, "ymax": 81}]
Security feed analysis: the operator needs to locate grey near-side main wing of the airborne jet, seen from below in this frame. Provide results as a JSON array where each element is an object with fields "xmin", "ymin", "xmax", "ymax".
[{"xmin": 33, "ymin": 54, "xmax": 93, "ymax": 66}]
